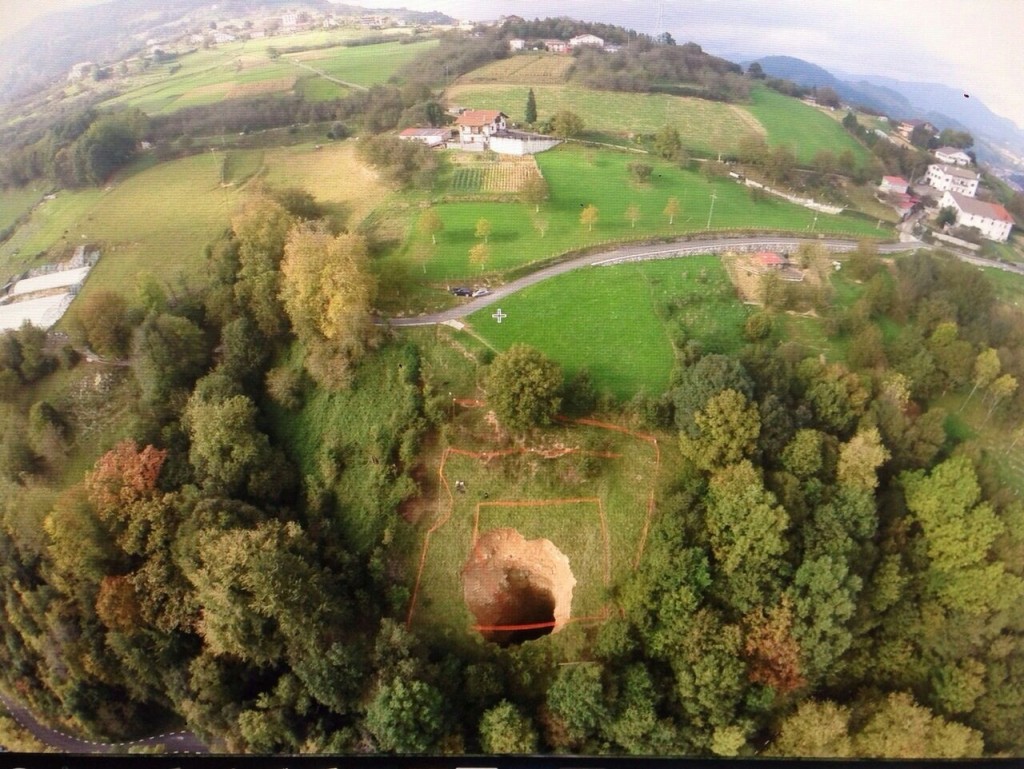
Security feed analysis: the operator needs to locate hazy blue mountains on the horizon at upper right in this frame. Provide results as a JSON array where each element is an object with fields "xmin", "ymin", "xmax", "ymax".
[{"xmin": 757, "ymin": 56, "xmax": 1024, "ymax": 167}]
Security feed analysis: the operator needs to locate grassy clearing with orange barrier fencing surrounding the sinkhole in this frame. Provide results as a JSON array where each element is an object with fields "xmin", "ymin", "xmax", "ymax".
[{"xmin": 411, "ymin": 417, "xmax": 657, "ymax": 638}]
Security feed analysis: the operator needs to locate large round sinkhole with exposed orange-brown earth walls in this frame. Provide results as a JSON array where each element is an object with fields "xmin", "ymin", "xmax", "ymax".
[{"xmin": 462, "ymin": 528, "xmax": 575, "ymax": 646}]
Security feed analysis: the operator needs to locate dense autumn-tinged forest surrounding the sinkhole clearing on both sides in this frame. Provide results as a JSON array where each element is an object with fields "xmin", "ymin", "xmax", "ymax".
[{"xmin": 0, "ymin": 191, "xmax": 1024, "ymax": 756}]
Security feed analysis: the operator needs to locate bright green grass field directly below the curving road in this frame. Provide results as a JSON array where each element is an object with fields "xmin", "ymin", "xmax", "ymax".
[{"xmin": 468, "ymin": 256, "xmax": 748, "ymax": 400}]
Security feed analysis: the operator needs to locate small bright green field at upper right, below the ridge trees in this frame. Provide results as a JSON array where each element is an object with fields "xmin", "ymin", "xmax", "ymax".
[{"xmin": 743, "ymin": 88, "xmax": 867, "ymax": 163}]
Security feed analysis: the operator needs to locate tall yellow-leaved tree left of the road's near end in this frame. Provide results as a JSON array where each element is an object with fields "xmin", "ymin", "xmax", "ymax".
[{"xmin": 281, "ymin": 224, "xmax": 377, "ymax": 389}]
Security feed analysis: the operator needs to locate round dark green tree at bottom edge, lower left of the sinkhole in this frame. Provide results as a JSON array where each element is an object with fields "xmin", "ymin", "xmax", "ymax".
[{"xmin": 367, "ymin": 676, "xmax": 443, "ymax": 753}]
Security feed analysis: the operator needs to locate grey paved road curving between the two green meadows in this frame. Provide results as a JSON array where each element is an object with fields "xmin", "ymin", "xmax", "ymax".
[{"xmin": 388, "ymin": 237, "xmax": 929, "ymax": 328}]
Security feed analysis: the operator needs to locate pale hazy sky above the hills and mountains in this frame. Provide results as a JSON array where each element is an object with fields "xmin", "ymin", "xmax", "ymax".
[{"xmin": 0, "ymin": 0, "xmax": 1024, "ymax": 128}]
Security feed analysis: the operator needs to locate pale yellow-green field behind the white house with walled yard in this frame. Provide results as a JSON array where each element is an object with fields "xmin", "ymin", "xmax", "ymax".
[{"xmin": 445, "ymin": 82, "xmax": 763, "ymax": 155}]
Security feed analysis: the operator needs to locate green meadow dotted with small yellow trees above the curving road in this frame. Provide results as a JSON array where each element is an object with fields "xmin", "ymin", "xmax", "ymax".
[{"xmin": 381, "ymin": 145, "xmax": 886, "ymax": 293}]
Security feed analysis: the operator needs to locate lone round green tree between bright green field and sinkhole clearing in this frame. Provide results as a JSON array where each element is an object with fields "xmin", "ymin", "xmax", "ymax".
[{"xmin": 486, "ymin": 344, "xmax": 562, "ymax": 432}]
